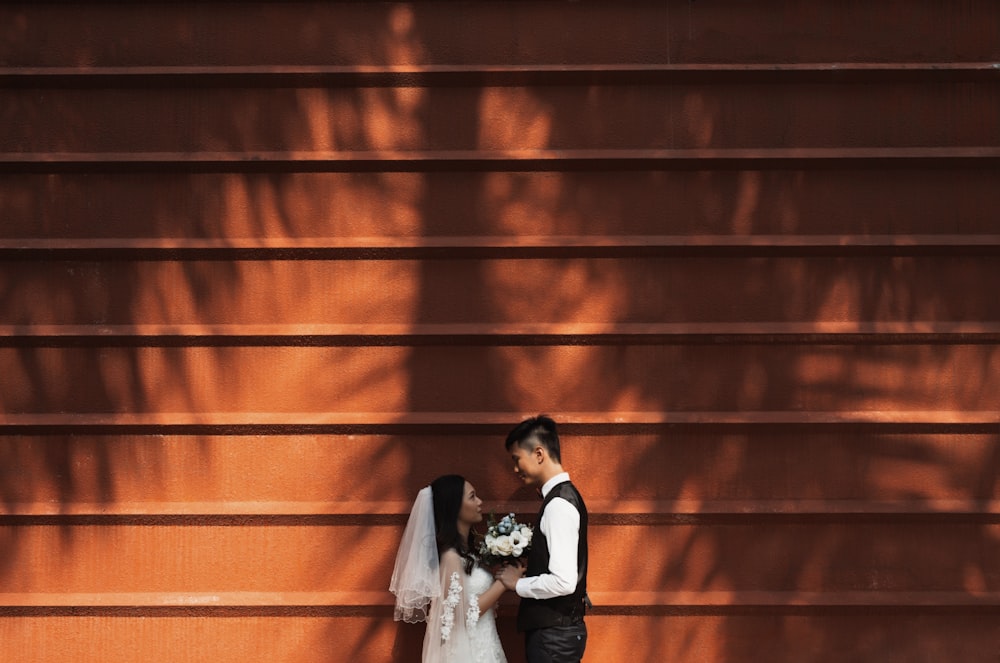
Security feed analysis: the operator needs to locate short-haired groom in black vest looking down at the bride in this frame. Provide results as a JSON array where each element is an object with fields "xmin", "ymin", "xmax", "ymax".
[{"xmin": 500, "ymin": 415, "xmax": 590, "ymax": 663}]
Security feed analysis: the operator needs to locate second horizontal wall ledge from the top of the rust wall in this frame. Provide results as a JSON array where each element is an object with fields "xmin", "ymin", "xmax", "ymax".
[{"xmin": 0, "ymin": 146, "xmax": 1000, "ymax": 173}]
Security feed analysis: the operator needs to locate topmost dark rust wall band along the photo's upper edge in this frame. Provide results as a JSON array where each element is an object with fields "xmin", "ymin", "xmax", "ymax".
[{"xmin": 0, "ymin": 0, "xmax": 1000, "ymax": 67}]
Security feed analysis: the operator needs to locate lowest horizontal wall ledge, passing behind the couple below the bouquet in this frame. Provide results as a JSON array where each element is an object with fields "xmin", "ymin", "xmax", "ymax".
[{"xmin": 0, "ymin": 590, "xmax": 1000, "ymax": 617}]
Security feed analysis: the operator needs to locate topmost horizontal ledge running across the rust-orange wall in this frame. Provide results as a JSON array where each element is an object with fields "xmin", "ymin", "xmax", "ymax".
[{"xmin": 0, "ymin": 62, "xmax": 1000, "ymax": 88}]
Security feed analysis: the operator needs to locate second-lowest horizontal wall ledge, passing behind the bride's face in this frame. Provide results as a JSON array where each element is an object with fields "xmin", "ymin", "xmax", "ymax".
[{"xmin": 0, "ymin": 498, "xmax": 1000, "ymax": 525}]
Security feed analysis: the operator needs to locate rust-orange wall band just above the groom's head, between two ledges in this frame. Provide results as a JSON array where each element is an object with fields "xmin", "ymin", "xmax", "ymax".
[{"xmin": 0, "ymin": 343, "xmax": 1000, "ymax": 416}]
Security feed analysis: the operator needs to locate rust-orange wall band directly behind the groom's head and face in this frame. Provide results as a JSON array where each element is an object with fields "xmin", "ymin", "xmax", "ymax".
[{"xmin": 0, "ymin": 434, "xmax": 1000, "ymax": 506}]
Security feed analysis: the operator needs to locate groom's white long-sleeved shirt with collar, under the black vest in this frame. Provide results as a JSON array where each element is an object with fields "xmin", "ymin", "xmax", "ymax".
[{"xmin": 515, "ymin": 472, "xmax": 580, "ymax": 599}]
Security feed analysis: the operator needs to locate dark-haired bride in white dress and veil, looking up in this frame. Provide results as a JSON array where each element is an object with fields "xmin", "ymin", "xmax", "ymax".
[{"xmin": 389, "ymin": 474, "xmax": 523, "ymax": 663}]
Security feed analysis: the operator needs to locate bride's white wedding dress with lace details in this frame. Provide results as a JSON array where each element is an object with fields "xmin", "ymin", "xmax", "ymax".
[{"xmin": 422, "ymin": 550, "xmax": 507, "ymax": 663}]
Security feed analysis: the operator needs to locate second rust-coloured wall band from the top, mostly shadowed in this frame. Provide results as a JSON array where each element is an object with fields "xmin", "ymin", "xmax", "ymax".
[{"xmin": 0, "ymin": 81, "xmax": 1000, "ymax": 152}]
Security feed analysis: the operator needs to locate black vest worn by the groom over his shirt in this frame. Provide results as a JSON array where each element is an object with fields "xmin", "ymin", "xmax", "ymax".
[{"xmin": 517, "ymin": 481, "xmax": 587, "ymax": 631}]
